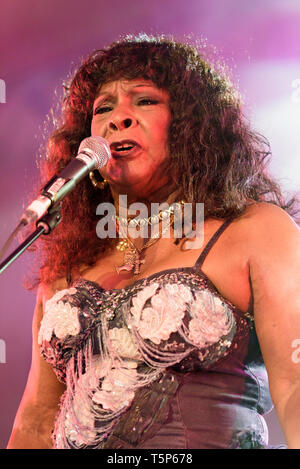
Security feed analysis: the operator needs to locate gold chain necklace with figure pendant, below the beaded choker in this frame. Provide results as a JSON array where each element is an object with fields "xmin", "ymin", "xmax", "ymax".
[{"xmin": 116, "ymin": 213, "xmax": 174, "ymax": 275}]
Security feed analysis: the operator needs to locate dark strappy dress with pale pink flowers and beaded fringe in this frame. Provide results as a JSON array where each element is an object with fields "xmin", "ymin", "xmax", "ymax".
[{"xmin": 39, "ymin": 219, "xmax": 280, "ymax": 449}]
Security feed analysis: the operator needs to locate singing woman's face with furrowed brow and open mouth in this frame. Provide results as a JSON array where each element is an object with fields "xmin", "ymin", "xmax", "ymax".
[{"xmin": 91, "ymin": 79, "xmax": 171, "ymax": 197}]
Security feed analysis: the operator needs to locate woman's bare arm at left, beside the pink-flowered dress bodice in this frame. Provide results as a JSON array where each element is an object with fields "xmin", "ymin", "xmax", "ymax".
[{"xmin": 7, "ymin": 286, "xmax": 65, "ymax": 449}]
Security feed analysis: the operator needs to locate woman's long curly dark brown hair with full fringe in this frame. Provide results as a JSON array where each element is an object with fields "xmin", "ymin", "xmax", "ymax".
[{"xmin": 29, "ymin": 34, "xmax": 293, "ymax": 283}]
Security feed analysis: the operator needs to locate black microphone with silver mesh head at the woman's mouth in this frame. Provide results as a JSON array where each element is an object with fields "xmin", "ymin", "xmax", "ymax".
[{"xmin": 20, "ymin": 137, "xmax": 111, "ymax": 225}]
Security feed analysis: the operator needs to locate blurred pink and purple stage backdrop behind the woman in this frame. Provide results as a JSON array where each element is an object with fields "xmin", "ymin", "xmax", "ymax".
[{"xmin": 0, "ymin": 0, "xmax": 300, "ymax": 448}]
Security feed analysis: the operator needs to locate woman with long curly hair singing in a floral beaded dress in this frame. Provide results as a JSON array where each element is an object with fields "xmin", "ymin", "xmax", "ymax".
[{"xmin": 8, "ymin": 35, "xmax": 300, "ymax": 449}]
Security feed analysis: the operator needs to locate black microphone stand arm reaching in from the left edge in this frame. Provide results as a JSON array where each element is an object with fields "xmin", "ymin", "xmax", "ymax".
[{"xmin": 0, "ymin": 205, "xmax": 61, "ymax": 274}]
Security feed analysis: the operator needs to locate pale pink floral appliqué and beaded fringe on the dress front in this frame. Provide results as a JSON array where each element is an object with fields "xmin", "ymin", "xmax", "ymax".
[{"xmin": 39, "ymin": 270, "xmax": 252, "ymax": 448}]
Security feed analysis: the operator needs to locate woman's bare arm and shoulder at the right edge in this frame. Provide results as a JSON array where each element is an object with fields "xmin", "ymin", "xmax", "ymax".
[{"xmin": 249, "ymin": 204, "xmax": 300, "ymax": 449}]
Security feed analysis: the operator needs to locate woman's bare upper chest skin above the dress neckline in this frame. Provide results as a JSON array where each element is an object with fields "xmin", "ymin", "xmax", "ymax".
[{"xmin": 80, "ymin": 221, "xmax": 251, "ymax": 312}]
